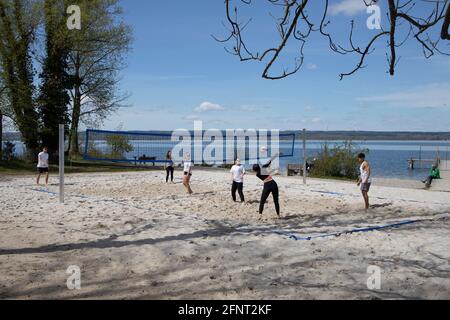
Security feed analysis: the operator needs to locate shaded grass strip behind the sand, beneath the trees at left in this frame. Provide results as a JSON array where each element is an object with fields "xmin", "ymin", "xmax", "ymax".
[{"xmin": 0, "ymin": 160, "xmax": 160, "ymax": 175}]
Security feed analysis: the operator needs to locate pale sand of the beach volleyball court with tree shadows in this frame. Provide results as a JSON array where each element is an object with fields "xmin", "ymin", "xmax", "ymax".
[{"xmin": 0, "ymin": 170, "xmax": 450, "ymax": 299}]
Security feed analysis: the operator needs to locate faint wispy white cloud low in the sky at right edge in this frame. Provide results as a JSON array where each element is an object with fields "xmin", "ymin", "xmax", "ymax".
[{"xmin": 356, "ymin": 83, "xmax": 450, "ymax": 108}]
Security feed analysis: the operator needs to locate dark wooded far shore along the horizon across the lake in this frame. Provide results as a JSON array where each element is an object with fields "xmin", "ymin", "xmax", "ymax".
[{"xmin": 3, "ymin": 130, "xmax": 450, "ymax": 141}]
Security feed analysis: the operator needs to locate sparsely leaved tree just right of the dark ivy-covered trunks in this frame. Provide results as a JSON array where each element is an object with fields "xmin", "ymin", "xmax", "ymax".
[{"xmin": 69, "ymin": 0, "xmax": 132, "ymax": 155}]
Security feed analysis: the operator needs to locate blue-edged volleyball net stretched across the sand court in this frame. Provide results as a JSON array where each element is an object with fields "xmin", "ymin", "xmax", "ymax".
[{"xmin": 83, "ymin": 129, "xmax": 296, "ymax": 165}]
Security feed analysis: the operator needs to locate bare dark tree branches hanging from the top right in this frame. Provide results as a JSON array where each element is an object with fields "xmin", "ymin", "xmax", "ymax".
[{"xmin": 213, "ymin": 0, "xmax": 450, "ymax": 80}]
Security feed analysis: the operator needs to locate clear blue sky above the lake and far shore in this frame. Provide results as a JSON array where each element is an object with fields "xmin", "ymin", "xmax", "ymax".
[{"xmin": 102, "ymin": 0, "xmax": 450, "ymax": 131}]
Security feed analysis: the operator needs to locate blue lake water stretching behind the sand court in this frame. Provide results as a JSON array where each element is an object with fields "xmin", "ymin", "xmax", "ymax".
[{"xmin": 5, "ymin": 141, "xmax": 450, "ymax": 179}]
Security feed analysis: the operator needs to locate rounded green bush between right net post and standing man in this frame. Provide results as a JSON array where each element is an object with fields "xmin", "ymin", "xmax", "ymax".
[{"xmin": 312, "ymin": 141, "xmax": 368, "ymax": 179}]
